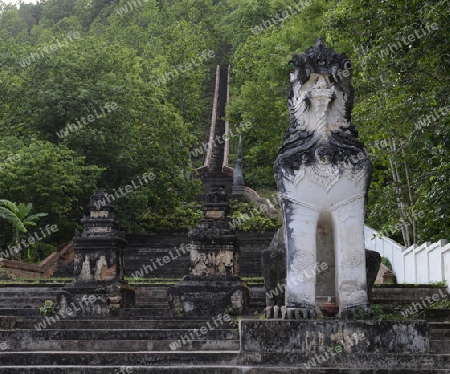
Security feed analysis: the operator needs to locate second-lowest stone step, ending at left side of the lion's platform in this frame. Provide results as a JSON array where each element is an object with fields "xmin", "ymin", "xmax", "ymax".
[{"xmin": 1, "ymin": 350, "xmax": 239, "ymax": 366}]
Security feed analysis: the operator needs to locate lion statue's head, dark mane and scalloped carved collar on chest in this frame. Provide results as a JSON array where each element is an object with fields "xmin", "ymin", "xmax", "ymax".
[{"xmin": 277, "ymin": 38, "xmax": 370, "ymax": 196}]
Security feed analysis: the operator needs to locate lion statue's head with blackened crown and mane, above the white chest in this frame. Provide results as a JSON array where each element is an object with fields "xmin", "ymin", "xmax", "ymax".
[{"xmin": 279, "ymin": 38, "xmax": 366, "ymax": 172}]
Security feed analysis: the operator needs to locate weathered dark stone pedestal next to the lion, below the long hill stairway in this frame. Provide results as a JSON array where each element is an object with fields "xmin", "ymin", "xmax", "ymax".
[{"xmin": 167, "ymin": 191, "xmax": 249, "ymax": 316}]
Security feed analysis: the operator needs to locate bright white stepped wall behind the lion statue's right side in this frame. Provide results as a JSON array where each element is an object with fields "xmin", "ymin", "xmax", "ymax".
[{"xmin": 364, "ymin": 226, "xmax": 450, "ymax": 290}]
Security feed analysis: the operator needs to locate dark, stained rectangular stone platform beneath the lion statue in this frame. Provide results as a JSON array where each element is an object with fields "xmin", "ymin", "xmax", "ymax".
[{"xmin": 240, "ymin": 319, "xmax": 429, "ymax": 368}]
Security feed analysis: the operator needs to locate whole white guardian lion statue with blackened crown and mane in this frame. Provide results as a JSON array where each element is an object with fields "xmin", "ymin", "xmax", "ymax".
[{"xmin": 274, "ymin": 38, "xmax": 371, "ymax": 318}]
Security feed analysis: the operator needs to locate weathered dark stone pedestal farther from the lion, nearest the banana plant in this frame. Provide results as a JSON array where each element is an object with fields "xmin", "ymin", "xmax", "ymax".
[{"xmin": 58, "ymin": 190, "xmax": 135, "ymax": 314}]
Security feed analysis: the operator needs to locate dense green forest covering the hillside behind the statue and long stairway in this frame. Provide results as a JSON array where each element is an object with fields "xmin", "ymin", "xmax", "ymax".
[{"xmin": 0, "ymin": 0, "xmax": 450, "ymax": 258}]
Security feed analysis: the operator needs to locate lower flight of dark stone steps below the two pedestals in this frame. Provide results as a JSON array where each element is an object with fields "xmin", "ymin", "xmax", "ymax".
[{"xmin": 0, "ymin": 317, "xmax": 450, "ymax": 374}]
